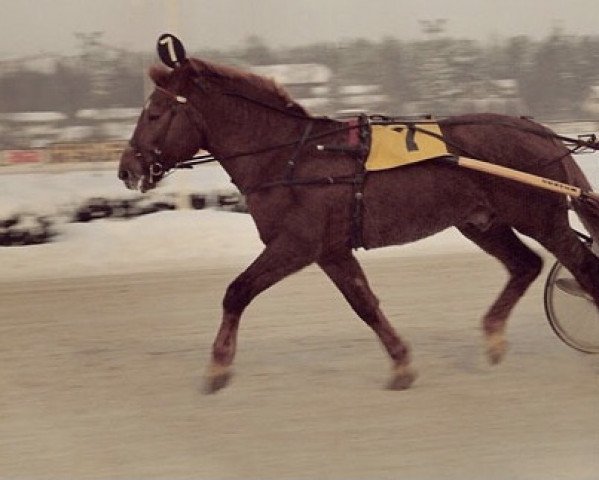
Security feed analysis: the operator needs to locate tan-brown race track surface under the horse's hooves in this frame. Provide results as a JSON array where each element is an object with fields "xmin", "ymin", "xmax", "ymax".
[{"xmin": 0, "ymin": 254, "xmax": 599, "ymax": 480}]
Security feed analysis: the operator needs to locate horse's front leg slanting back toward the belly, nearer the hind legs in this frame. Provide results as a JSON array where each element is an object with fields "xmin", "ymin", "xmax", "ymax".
[{"xmin": 318, "ymin": 250, "xmax": 416, "ymax": 390}]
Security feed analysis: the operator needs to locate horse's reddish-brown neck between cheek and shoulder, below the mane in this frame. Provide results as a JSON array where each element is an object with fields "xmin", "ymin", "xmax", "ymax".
[{"xmin": 198, "ymin": 93, "xmax": 310, "ymax": 191}]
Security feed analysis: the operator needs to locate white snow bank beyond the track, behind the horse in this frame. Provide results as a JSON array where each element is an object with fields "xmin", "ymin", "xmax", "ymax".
[{"xmin": 0, "ymin": 154, "xmax": 599, "ymax": 280}]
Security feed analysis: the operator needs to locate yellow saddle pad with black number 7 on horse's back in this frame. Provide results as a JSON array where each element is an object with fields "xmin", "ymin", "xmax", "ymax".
[{"xmin": 366, "ymin": 122, "xmax": 449, "ymax": 171}]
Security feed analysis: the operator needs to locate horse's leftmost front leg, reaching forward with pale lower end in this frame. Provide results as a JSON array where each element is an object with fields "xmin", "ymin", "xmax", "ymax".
[{"xmin": 205, "ymin": 236, "xmax": 317, "ymax": 393}]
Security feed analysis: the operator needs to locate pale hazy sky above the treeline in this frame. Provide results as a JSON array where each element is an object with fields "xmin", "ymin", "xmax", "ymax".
[{"xmin": 0, "ymin": 0, "xmax": 599, "ymax": 59}]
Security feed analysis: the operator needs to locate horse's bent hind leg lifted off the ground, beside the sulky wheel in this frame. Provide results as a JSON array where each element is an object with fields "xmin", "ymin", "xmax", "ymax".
[{"xmin": 459, "ymin": 225, "xmax": 543, "ymax": 364}]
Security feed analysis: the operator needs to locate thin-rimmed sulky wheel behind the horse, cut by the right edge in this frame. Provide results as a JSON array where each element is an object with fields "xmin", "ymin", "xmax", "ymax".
[{"xmin": 545, "ymin": 256, "xmax": 599, "ymax": 353}]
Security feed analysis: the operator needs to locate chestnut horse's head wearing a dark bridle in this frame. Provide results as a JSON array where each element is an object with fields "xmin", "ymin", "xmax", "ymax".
[{"xmin": 118, "ymin": 37, "xmax": 204, "ymax": 192}]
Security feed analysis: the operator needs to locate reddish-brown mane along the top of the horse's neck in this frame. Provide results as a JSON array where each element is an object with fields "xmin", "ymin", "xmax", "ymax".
[{"xmin": 191, "ymin": 58, "xmax": 309, "ymax": 116}]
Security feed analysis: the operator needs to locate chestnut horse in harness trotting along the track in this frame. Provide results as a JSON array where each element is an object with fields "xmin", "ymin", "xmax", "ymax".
[{"xmin": 119, "ymin": 47, "xmax": 599, "ymax": 392}]
